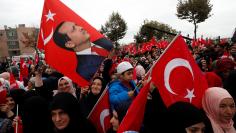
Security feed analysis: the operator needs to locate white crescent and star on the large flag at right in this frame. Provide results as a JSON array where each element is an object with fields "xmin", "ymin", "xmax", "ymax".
[{"xmin": 164, "ymin": 58, "xmax": 195, "ymax": 103}]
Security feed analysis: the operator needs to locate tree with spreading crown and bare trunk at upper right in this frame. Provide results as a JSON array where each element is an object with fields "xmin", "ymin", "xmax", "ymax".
[{"xmin": 176, "ymin": 0, "xmax": 212, "ymax": 39}]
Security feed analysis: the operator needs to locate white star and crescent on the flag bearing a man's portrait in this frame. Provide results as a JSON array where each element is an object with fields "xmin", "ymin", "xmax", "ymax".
[{"xmin": 41, "ymin": 9, "xmax": 56, "ymax": 45}]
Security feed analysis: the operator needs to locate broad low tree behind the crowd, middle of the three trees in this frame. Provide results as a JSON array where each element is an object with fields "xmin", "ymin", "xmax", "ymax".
[{"xmin": 134, "ymin": 20, "xmax": 177, "ymax": 43}]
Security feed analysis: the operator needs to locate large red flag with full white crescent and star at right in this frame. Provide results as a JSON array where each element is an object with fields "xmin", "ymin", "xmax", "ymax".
[{"xmin": 151, "ymin": 35, "xmax": 207, "ymax": 108}]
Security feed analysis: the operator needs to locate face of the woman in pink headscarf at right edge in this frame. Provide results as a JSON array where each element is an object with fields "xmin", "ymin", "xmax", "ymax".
[{"xmin": 218, "ymin": 98, "xmax": 235, "ymax": 123}]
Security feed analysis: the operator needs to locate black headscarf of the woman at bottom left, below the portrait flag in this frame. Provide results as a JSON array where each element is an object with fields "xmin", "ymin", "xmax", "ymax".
[{"xmin": 50, "ymin": 92, "xmax": 96, "ymax": 133}]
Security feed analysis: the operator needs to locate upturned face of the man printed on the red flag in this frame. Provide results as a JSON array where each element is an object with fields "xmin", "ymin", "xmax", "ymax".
[{"xmin": 59, "ymin": 22, "xmax": 90, "ymax": 48}]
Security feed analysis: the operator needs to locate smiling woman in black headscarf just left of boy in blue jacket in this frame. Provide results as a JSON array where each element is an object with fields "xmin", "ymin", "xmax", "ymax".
[{"xmin": 80, "ymin": 77, "xmax": 105, "ymax": 117}]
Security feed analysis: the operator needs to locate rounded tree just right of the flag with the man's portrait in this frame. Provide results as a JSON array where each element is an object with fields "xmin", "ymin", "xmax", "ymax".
[{"xmin": 100, "ymin": 12, "xmax": 127, "ymax": 48}]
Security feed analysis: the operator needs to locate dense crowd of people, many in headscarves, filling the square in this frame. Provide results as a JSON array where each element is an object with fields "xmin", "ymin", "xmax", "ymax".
[{"xmin": 0, "ymin": 32, "xmax": 236, "ymax": 133}]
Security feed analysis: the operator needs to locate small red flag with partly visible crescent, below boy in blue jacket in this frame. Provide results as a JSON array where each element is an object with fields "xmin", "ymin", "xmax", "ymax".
[{"xmin": 88, "ymin": 88, "xmax": 111, "ymax": 133}]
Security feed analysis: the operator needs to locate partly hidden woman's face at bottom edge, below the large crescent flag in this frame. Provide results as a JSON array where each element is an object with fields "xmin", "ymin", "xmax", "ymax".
[{"xmin": 185, "ymin": 122, "xmax": 205, "ymax": 133}]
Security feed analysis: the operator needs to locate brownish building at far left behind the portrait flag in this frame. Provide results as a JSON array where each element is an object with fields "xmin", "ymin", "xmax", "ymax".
[{"xmin": 0, "ymin": 24, "xmax": 38, "ymax": 60}]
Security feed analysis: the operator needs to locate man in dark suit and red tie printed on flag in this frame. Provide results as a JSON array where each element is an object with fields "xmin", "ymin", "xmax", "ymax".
[{"xmin": 53, "ymin": 21, "xmax": 112, "ymax": 81}]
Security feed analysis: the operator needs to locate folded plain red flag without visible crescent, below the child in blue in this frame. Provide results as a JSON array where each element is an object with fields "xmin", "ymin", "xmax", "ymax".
[{"xmin": 117, "ymin": 81, "xmax": 151, "ymax": 133}]
